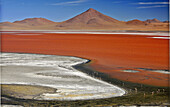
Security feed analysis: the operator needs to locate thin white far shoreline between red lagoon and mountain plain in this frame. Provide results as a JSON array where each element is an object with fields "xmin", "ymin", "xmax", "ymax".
[{"xmin": 0, "ymin": 30, "xmax": 169, "ymax": 37}]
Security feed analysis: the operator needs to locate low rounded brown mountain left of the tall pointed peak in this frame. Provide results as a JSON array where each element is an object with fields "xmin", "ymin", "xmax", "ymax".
[{"xmin": 13, "ymin": 18, "xmax": 56, "ymax": 26}]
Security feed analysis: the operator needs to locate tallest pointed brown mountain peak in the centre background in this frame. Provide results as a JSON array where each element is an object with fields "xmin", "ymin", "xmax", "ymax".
[{"xmin": 57, "ymin": 8, "xmax": 122, "ymax": 27}]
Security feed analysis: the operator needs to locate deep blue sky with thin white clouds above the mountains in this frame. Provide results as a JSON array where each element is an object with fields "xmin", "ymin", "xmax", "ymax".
[{"xmin": 1, "ymin": 0, "xmax": 169, "ymax": 22}]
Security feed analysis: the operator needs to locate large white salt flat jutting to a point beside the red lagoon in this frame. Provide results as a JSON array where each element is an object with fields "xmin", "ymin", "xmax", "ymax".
[{"xmin": 1, "ymin": 53, "xmax": 125, "ymax": 100}]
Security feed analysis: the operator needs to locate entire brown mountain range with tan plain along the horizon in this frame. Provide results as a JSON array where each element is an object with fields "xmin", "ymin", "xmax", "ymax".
[{"xmin": 0, "ymin": 8, "xmax": 169, "ymax": 30}]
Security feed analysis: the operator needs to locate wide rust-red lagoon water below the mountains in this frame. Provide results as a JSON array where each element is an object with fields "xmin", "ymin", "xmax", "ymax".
[{"xmin": 1, "ymin": 32, "xmax": 169, "ymax": 86}]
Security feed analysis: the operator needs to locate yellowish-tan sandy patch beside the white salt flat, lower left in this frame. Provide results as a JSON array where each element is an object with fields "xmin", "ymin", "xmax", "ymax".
[{"xmin": 1, "ymin": 84, "xmax": 57, "ymax": 101}]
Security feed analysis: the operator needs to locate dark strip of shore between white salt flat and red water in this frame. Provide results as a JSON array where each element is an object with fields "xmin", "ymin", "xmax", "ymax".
[{"xmin": 73, "ymin": 63, "xmax": 169, "ymax": 91}]
